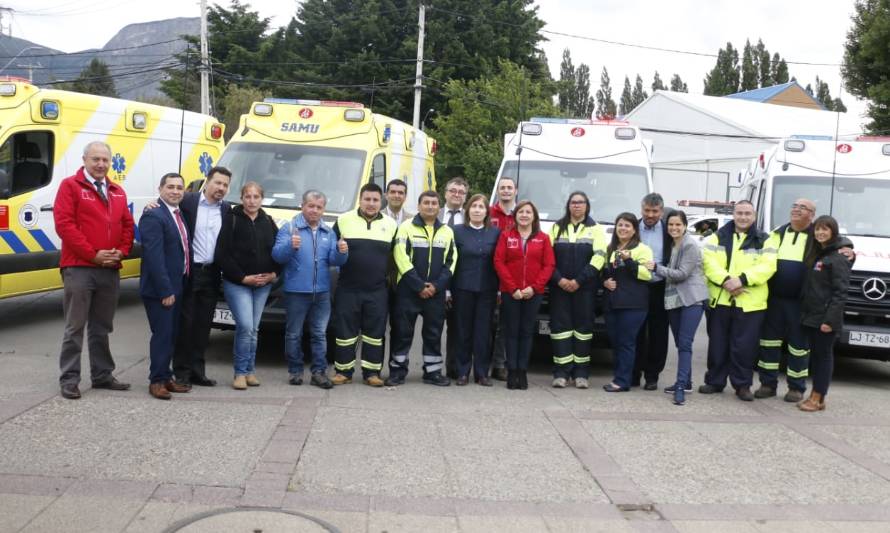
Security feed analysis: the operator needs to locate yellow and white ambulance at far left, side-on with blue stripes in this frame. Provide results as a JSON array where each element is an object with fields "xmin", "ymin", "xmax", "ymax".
[{"xmin": 0, "ymin": 78, "xmax": 223, "ymax": 298}]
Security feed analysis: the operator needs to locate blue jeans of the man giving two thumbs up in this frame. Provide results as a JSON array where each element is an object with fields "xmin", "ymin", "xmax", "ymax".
[{"xmin": 284, "ymin": 292, "xmax": 331, "ymax": 376}]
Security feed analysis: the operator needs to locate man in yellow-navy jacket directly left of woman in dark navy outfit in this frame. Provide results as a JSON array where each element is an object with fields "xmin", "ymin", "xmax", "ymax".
[{"xmin": 386, "ymin": 191, "xmax": 457, "ymax": 387}]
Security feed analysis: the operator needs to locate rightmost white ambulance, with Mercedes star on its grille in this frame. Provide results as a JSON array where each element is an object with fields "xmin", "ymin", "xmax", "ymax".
[{"xmin": 738, "ymin": 136, "xmax": 890, "ymax": 360}]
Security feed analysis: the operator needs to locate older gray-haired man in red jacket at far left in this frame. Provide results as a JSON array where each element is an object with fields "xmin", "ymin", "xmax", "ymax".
[{"xmin": 53, "ymin": 141, "xmax": 133, "ymax": 400}]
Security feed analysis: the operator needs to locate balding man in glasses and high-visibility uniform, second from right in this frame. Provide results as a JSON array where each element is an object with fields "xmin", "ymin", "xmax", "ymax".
[{"xmin": 754, "ymin": 198, "xmax": 816, "ymax": 402}]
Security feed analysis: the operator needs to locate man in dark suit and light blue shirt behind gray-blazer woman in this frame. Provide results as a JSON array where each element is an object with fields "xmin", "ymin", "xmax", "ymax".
[{"xmin": 631, "ymin": 192, "xmax": 672, "ymax": 392}]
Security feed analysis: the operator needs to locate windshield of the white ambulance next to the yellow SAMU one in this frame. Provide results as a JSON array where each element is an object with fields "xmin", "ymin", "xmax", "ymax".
[{"xmin": 501, "ymin": 161, "xmax": 649, "ymax": 224}]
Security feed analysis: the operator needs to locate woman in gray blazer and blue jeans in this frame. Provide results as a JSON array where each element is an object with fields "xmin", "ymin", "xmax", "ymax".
[{"xmin": 646, "ymin": 211, "xmax": 708, "ymax": 405}]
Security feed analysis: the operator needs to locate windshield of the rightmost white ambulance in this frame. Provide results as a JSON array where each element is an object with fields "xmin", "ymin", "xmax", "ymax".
[{"xmin": 771, "ymin": 176, "xmax": 890, "ymax": 237}]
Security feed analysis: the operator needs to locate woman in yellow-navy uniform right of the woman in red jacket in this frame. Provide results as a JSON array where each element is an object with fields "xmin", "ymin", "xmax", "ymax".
[{"xmin": 550, "ymin": 191, "xmax": 606, "ymax": 389}]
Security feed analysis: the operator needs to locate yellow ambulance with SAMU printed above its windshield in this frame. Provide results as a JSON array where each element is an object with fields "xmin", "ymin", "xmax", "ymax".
[{"xmin": 220, "ymin": 98, "xmax": 437, "ymax": 216}]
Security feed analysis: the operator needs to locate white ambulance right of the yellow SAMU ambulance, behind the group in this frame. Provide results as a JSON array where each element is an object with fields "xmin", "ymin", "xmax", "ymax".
[{"xmin": 491, "ymin": 118, "xmax": 652, "ymax": 334}]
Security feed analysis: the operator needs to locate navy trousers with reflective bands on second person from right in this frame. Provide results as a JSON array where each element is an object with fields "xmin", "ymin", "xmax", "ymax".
[{"xmin": 757, "ymin": 297, "xmax": 810, "ymax": 392}]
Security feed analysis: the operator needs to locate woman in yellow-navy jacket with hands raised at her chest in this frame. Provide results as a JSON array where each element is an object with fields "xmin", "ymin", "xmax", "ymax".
[{"xmin": 603, "ymin": 213, "xmax": 652, "ymax": 392}]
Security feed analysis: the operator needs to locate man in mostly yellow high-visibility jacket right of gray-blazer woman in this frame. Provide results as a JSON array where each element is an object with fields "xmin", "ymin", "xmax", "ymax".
[{"xmin": 698, "ymin": 200, "xmax": 776, "ymax": 402}]
